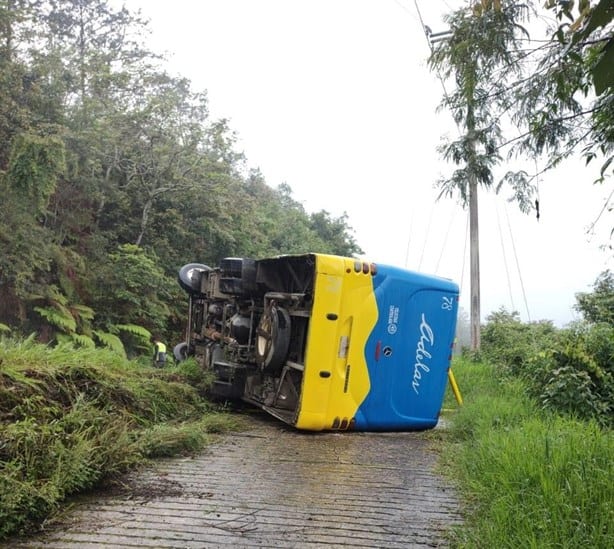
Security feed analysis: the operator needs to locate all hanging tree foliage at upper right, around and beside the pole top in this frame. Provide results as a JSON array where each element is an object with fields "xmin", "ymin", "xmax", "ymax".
[{"xmin": 430, "ymin": 0, "xmax": 614, "ymax": 223}]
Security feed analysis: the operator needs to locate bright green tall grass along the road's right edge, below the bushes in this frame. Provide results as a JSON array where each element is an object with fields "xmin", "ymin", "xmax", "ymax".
[{"xmin": 443, "ymin": 359, "xmax": 614, "ymax": 549}]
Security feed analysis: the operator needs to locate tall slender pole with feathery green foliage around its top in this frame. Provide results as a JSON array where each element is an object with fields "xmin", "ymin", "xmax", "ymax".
[{"xmin": 429, "ymin": 0, "xmax": 531, "ymax": 350}]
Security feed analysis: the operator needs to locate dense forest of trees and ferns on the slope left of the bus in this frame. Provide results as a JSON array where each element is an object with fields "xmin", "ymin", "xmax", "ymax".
[{"xmin": 0, "ymin": 0, "xmax": 360, "ymax": 352}]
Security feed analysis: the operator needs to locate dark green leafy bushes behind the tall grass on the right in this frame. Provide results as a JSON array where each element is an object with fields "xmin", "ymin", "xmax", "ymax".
[{"xmin": 481, "ymin": 310, "xmax": 614, "ymax": 427}]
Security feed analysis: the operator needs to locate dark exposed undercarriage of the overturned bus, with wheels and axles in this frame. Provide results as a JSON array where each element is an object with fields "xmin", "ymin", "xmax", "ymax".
[{"xmin": 174, "ymin": 255, "xmax": 315, "ymax": 423}]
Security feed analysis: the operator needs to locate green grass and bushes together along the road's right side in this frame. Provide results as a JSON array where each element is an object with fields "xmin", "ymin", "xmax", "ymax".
[{"xmin": 443, "ymin": 272, "xmax": 614, "ymax": 549}]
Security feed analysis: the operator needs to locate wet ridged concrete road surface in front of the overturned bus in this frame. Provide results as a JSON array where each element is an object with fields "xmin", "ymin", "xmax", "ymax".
[{"xmin": 7, "ymin": 414, "xmax": 460, "ymax": 549}]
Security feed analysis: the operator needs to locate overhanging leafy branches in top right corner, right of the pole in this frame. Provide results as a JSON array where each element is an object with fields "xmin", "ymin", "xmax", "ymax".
[{"xmin": 510, "ymin": 0, "xmax": 614, "ymax": 181}]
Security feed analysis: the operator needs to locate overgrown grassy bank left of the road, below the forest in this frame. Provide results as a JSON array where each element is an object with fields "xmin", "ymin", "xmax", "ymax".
[{"xmin": 0, "ymin": 339, "xmax": 244, "ymax": 539}]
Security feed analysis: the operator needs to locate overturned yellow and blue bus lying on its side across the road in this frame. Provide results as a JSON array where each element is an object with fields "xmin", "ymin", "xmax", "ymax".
[{"xmin": 174, "ymin": 253, "xmax": 459, "ymax": 431}]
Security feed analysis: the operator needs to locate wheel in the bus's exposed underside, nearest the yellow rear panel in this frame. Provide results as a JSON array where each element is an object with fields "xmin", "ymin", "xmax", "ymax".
[{"xmin": 256, "ymin": 305, "xmax": 290, "ymax": 373}]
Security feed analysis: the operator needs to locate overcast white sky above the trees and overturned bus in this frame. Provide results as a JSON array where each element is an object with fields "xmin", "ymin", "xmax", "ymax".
[{"xmin": 121, "ymin": 0, "xmax": 614, "ymax": 326}]
